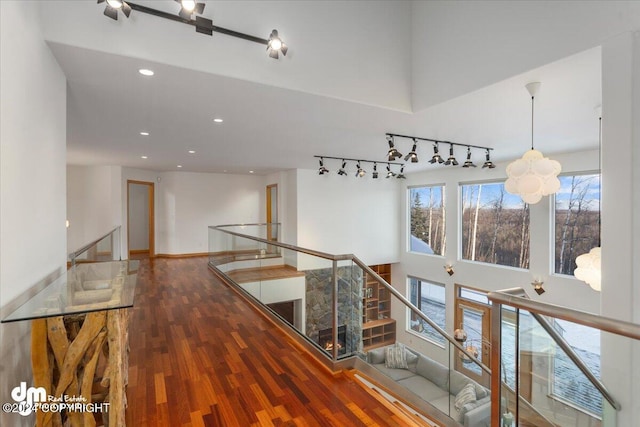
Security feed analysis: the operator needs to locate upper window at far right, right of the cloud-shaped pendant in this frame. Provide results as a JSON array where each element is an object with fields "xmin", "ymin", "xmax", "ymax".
[{"xmin": 554, "ymin": 174, "xmax": 600, "ymax": 275}]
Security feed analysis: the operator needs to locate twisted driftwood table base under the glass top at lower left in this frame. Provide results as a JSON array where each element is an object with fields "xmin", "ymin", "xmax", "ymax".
[{"xmin": 31, "ymin": 309, "xmax": 129, "ymax": 427}]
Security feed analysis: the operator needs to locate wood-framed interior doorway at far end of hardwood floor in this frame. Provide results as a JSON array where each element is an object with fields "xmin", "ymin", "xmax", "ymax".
[{"xmin": 127, "ymin": 180, "xmax": 155, "ymax": 259}]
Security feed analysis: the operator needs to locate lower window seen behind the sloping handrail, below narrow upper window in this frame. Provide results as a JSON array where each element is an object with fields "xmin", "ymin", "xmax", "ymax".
[{"xmin": 407, "ymin": 277, "xmax": 446, "ymax": 345}]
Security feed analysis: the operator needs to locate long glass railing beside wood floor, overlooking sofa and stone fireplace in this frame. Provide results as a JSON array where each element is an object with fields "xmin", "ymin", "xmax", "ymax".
[{"xmin": 209, "ymin": 224, "xmax": 491, "ymax": 427}]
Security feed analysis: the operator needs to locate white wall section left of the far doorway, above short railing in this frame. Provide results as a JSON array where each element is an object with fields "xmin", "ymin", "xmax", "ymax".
[{"xmin": 67, "ymin": 165, "xmax": 122, "ymax": 253}]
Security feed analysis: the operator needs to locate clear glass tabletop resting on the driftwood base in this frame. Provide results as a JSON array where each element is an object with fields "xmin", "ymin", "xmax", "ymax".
[{"xmin": 2, "ymin": 260, "xmax": 140, "ymax": 323}]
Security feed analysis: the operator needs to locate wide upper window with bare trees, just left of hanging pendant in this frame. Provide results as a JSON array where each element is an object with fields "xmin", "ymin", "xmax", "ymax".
[{"xmin": 461, "ymin": 183, "xmax": 530, "ymax": 268}]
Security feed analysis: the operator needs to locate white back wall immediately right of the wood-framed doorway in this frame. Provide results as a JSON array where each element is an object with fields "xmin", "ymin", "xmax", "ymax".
[{"xmin": 156, "ymin": 172, "xmax": 266, "ymax": 254}]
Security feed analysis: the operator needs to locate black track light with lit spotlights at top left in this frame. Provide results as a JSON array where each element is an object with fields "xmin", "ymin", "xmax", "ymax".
[{"xmin": 98, "ymin": 0, "xmax": 287, "ymax": 59}]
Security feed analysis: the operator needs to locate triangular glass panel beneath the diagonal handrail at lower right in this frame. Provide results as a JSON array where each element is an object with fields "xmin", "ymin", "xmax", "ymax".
[{"xmin": 516, "ymin": 310, "xmax": 603, "ymax": 427}]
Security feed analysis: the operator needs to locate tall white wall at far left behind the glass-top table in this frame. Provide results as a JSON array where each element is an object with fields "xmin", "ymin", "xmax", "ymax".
[{"xmin": 0, "ymin": 1, "xmax": 67, "ymax": 426}]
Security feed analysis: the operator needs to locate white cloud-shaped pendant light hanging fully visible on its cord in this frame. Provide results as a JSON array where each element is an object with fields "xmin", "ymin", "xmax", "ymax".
[{"xmin": 504, "ymin": 82, "xmax": 562, "ymax": 204}]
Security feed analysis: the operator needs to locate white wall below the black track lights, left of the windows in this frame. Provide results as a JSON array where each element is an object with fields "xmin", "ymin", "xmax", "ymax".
[{"xmin": 296, "ymin": 165, "xmax": 400, "ymax": 265}]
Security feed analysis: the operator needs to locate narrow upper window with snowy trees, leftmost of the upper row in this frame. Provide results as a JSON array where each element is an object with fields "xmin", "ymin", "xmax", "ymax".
[{"xmin": 409, "ymin": 185, "xmax": 445, "ymax": 255}]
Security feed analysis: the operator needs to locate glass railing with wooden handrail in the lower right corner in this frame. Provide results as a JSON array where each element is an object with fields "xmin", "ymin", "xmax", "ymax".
[{"xmin": 489, "ymin": 288, "xmax": 640, "ymax": 427}]
